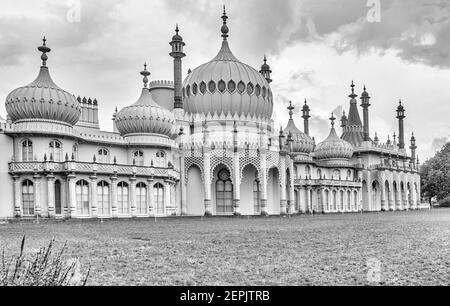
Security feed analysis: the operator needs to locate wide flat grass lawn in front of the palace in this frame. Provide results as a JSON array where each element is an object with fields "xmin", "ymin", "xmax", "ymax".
[{"xmin": 0, "ymin": 209, "xmax": 450, "ymax": 285}]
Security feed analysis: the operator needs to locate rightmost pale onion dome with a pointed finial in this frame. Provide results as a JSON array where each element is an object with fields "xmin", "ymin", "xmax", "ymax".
[{"xmin": 314, "ymin": 115, "xmax": 353, "ymax": 160}]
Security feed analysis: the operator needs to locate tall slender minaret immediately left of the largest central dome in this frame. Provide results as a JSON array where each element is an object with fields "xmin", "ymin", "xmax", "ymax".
[{"xmin": 170, "ymin": 24, "xmax": 186, "ymax": 111}]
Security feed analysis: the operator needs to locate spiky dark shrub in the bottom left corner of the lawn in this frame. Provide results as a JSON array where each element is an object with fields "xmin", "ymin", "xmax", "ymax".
[{"xmin": 0, "ymin": 236, "xmax": 90, "ymax": 286}]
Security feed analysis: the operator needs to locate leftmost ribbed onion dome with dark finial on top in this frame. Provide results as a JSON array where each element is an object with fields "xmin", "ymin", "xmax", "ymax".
[{"xmin": 5, "ymin": 37, "xmax": 81, "ymax": 126}]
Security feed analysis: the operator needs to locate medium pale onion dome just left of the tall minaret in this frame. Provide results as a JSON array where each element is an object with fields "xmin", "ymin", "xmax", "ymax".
[{"xmin": 115, "ymin": 64, "xmax": 175, "ymax": 137}]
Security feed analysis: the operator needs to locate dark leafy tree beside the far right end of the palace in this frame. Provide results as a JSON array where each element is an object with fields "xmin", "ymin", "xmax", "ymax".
[{"xmin": 420, "ymin": 143, "xmax": 450, "ymax": 201}]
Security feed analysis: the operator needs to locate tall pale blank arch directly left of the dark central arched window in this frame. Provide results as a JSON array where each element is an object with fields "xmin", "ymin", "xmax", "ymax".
[{"xmin": 186, "ymin": 165, "xmax": 205, "ymax": 216}]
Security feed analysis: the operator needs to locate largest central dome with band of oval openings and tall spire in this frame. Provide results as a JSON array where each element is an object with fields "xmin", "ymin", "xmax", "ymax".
[{"xmin": 183, "ymin": 7, "xmax": 273, "ymax": 119}]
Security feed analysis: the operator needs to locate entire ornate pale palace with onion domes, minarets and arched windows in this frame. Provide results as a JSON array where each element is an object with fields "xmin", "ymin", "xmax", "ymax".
[{"xmin": 0, "ymin": 11, "xmax": 420, "ymax": 218}]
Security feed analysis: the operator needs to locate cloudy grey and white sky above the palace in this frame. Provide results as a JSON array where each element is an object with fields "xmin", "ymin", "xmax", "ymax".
[{"xmin": 0, "ymin": 0, "xmax": 450, "ymax": 160}]
